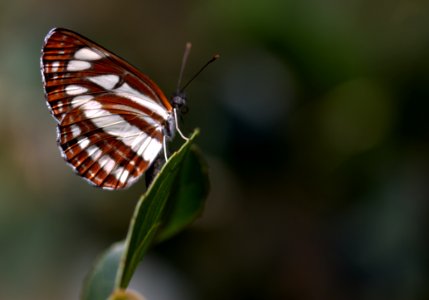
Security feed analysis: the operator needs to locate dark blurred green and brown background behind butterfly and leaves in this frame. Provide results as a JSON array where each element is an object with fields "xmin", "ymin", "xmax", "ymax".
[{"xmin": 0, "ymin": 0, "xmax": 429, "ymax": 300}]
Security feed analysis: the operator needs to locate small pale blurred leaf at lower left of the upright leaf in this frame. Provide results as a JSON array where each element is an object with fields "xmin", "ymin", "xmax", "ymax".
[{"xmin": 81, "ymin": 242, "xmax": 125, "ymax": 300}]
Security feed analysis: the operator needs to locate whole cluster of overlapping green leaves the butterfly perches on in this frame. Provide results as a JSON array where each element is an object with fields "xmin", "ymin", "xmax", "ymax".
[{"xmin": 82, "ymin": 130, "xmax": 209, "ymax": 300}]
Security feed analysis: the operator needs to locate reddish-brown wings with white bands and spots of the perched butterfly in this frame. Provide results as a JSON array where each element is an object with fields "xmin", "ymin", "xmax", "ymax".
[{"xmin": 41, "ymin": 28, "xmax": 173, "ymax": 189}]
